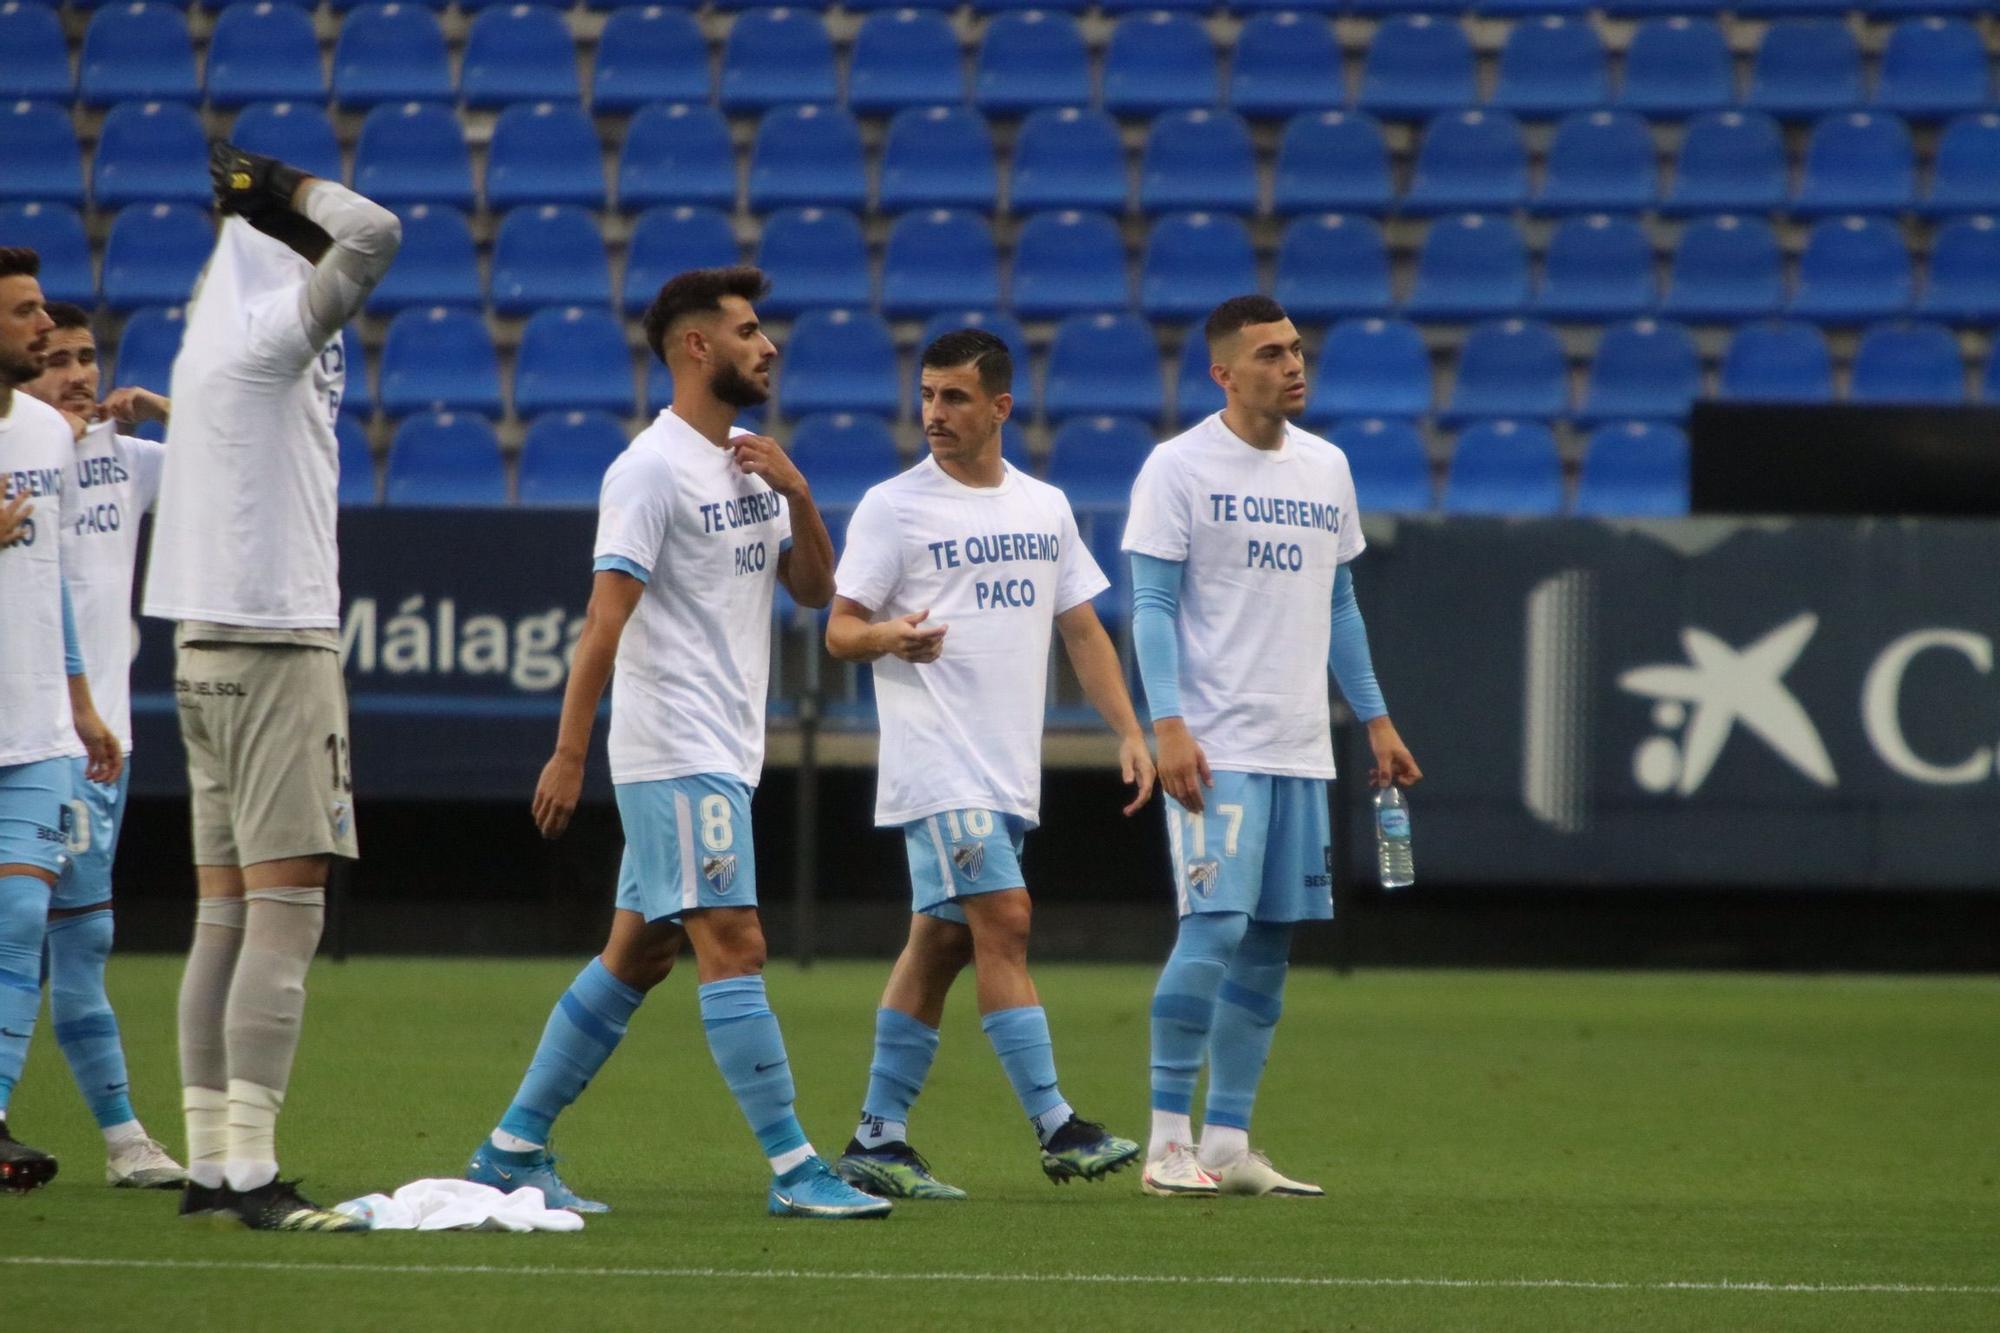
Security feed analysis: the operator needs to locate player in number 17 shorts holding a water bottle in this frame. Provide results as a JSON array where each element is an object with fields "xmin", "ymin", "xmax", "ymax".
[{"xmin": 1124, "ymin": 296, "xmax": 1422, "ymax": 1197}]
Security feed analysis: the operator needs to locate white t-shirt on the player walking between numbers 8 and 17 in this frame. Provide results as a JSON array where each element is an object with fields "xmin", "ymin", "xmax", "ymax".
[{"xmin": 834, "ymin": 458, "xmax": 1110, "ymax": 825}]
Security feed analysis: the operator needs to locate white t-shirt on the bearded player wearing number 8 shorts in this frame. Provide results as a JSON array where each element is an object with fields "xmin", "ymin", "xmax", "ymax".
[{"xmin": 594, "ymin": 408, "xmax": 792, "ymax": 787}]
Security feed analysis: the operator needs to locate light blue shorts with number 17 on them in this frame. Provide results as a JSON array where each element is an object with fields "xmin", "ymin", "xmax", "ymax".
[{"xmin": 1166, "ymin": 773, "xmax": 1334, "ymax": 923}]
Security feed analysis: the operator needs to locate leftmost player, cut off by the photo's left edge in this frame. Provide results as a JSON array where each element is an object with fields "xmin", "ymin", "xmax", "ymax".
[{"xmin": 0, "ymin": 246, "xmax": 124, "ymax": 1189}]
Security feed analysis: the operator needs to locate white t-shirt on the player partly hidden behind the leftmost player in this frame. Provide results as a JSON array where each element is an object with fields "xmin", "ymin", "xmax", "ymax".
[{"xmin": 62, "ymin": 422, "xmax": 166, "ymax": 755}]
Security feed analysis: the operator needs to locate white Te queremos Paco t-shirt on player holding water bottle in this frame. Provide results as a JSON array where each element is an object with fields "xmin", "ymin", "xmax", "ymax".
[{"xmin": 1124, "ymin": 412, "xmax": 1366, "ymax": 779}]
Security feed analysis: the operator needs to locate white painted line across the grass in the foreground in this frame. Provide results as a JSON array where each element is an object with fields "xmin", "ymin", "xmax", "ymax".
[{"xmin": 0, "ymin": 1241, "xmax": 2000, "ymax": 1297}]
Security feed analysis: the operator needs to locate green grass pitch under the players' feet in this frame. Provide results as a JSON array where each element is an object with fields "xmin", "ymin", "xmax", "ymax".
[{"xmin": 0, "ymin": 957, "xmax": 2000, "ymax": 1333}]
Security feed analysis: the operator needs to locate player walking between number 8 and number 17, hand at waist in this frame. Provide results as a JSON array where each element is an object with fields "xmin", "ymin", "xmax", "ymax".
[{"xmin": 826, "ymin": 328, "xmax": 1154, "ymax": 1199}]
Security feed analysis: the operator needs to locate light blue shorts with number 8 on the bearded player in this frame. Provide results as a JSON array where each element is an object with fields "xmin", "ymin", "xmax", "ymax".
[{"xmin": 612, "ymin": 773, "xmax": 756, "ymax": 921}]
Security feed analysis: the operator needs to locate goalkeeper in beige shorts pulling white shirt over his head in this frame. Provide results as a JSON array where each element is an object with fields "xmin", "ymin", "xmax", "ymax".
[{"xmin": 146, "ymin": 144, "xmax": 402, "ymax": 1231}]
